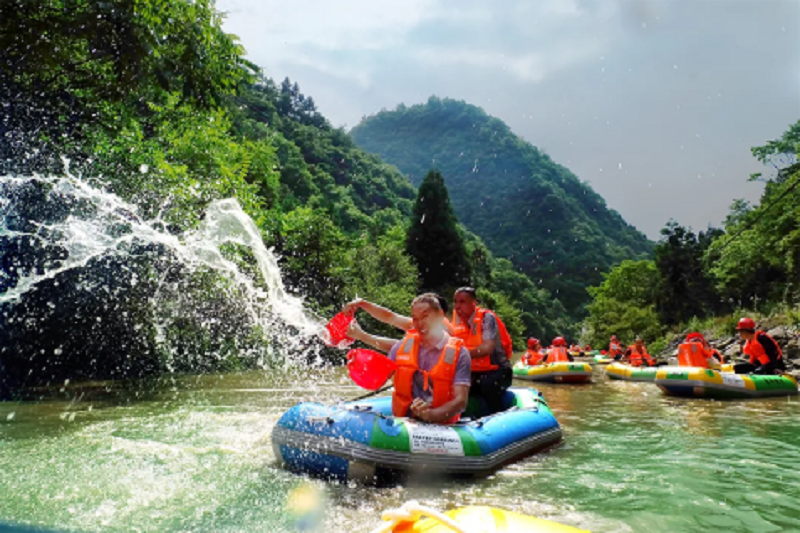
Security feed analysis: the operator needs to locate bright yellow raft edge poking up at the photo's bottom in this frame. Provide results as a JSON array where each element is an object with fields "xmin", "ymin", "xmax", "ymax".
[{"xmin": 374, "ymin": 501, "xmax": 585, "ymax": 533}]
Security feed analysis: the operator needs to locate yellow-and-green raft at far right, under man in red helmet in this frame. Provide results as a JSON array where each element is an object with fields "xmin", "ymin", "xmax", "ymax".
[{"xmin": 655, "ymin": 366, "xmax": 798, "ymax": 399}]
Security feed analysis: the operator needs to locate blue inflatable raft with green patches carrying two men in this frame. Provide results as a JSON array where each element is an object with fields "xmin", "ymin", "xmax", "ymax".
[{"xmin": 272, "ymin": 387, "xmax": 561, "ymax": 483}]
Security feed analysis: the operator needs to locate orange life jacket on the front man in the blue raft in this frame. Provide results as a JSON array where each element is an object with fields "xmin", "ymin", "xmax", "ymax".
[{"xmin": 392, "ymin": 332, "xmax": 464, "ymax": 424}]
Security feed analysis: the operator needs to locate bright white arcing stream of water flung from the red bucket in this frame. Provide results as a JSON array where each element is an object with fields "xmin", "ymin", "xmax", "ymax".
[{"xmin": 0, "ymin": 168, "xmax": 321, "ymax": 368}]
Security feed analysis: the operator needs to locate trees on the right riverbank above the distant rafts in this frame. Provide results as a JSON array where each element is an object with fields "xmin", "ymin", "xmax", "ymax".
[{"xmin": 585, "ymin": 121, "xmax": 800, "ymax": 354}]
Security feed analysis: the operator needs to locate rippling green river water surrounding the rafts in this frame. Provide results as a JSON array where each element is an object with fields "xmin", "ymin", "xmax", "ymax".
[{"xmin": 0, "ymin": 362, "xmax": 800, "ymax": 533}]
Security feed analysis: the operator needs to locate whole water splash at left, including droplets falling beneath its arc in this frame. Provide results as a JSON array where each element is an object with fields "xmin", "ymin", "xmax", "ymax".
[{"xmin": 0, "ymin": 168, "xmax": 321, "ymax": 379}]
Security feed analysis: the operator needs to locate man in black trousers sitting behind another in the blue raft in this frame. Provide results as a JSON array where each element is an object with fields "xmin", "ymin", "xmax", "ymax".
[{"xmin": 451, "ymin": 287, "xmax": 513, "ymax": 413}]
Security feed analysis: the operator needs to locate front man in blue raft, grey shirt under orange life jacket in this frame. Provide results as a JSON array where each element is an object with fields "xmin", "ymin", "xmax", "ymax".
[{"xmin": 347, "ymin": 293, "xmax": 471, "ymax": 424}]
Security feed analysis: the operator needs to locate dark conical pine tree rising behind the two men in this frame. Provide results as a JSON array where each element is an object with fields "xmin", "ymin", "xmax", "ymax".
[{"xmin": 406, "ymin": 170, "xmax": 470, "ymax": 292}]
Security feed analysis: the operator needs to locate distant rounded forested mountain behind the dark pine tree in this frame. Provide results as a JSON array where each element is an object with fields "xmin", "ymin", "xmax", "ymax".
[{"xmin": 351, "ymin": 97, "xmax": 652, "ymax": 314}]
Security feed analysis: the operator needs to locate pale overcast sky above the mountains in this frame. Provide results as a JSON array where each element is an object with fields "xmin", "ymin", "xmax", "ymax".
[{"xmin": 217, "ymin": 0, "xmax": 800, "ymax": 238}]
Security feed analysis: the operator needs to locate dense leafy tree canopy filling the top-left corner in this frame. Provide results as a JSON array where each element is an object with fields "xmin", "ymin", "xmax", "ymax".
[{"xmin": 0, "ymin": 0, "xmax": 253, "ymax": 170}]
